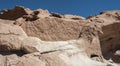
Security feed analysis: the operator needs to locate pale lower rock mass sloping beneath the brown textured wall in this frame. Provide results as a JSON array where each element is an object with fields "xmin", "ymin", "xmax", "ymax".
[{"xmin": 0, "ymin": 23, "xmax": 106, "ymax": 66}]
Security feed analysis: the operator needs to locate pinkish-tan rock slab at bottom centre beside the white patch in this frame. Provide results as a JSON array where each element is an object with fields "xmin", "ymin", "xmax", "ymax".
[{"xmin": 40, "ymin": 52, "xmax": 72, "ymax": 66}]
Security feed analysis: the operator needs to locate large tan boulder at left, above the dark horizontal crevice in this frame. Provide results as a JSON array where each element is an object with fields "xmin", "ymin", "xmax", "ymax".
[{"xmin": 0, "ymin": 23, "xmax": 42, "ymax": 54}]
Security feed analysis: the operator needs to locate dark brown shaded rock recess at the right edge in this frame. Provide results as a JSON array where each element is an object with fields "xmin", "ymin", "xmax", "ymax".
[{"xmin": 100, "ymin": 23, "xmax": 120, "ymax": 63}]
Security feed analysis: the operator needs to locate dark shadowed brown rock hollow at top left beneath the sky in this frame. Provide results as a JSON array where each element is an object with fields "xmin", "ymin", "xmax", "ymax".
[{"xmin": 0, "ymin": 6, "xmax": 29, "ymax": 20}]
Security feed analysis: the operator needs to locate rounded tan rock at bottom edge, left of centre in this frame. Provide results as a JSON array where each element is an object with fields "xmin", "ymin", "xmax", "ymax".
[{"xmin": 16, "ymin": 54, "xmax": 46, "ymax": 66}]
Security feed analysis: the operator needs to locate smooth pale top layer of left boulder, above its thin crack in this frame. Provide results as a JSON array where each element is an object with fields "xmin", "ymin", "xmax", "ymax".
[{"xmin": 0, "ymin": 23, "xmax": 27, "ymax": 37}]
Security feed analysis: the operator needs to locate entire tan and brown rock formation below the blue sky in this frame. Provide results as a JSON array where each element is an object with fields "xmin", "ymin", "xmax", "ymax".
[{"xmin": 0, "ymin": 6, "xmax": 120, "ymax": 66}]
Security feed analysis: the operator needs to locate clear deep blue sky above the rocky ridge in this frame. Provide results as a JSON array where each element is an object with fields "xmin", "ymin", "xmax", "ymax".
[{"xmin": 0, "ymin": 0, "xmax": 120, "ymax": 17}]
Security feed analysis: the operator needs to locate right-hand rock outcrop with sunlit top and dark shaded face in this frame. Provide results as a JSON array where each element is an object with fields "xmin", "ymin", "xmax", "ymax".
[{"xmin": 89, "ymin": 10, "xmax": 120, "ymax": 62}]
